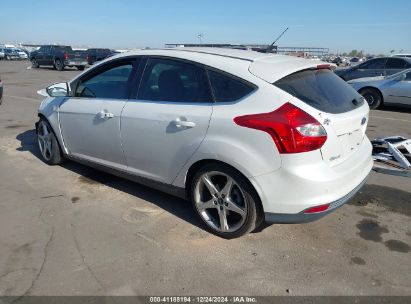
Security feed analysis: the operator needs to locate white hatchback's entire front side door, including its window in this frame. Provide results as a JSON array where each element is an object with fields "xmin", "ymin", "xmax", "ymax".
[{"xmin": 59, "ymin": 58, "xmax": 138, "ymax": 170}]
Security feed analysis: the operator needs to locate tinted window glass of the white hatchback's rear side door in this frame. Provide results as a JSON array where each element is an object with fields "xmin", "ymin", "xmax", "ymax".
[{"xmin": 138, "ymin": 58, "xmax": 212, "ymax": 103}]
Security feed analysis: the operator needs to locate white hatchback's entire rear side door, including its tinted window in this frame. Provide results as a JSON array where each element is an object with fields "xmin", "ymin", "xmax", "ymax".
[{"xmin": 121, "ymin": 58, "xmax": 213, "ymax": 184}]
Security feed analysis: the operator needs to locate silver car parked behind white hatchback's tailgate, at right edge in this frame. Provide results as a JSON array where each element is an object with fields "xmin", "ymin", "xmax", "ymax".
[{"xmin": 348, "ymin": 69, "xmax": 411, "ymax": 109}]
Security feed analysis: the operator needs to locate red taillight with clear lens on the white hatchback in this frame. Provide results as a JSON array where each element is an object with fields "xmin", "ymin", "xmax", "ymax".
[{"xmin": 234, "ymin": 102, "xmax": 327, "ymax": 154}]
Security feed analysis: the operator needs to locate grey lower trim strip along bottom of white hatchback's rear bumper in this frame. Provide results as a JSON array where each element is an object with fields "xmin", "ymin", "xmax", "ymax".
[{"xmin": 264, "ymin": 176, "xmax": 368, "ymax": 224}]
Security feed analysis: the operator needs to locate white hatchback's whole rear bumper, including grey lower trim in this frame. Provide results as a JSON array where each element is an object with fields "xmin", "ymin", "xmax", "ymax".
[{"xmin": 250, "ymin": 138, "xmax": 373, "ymax": 223}]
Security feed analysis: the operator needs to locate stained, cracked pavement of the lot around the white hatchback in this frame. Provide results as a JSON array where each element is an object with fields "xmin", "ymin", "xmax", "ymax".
[{"xmin": 0, "ymin": 61, "xmax": 411, "ymax": 296}]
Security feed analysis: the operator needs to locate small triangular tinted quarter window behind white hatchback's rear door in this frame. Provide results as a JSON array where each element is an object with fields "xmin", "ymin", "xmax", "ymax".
[{"xmin": 207, "ymin": 70, "xmax": 254, "ymax": 102}]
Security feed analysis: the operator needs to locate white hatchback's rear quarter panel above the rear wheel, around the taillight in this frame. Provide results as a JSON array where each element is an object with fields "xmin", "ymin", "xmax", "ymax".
[{"xmin": 173, "ymin": 77, "xmax": 290, "ymax": 187}]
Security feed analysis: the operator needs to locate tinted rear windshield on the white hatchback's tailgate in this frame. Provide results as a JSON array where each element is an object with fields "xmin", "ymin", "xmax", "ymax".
[{"xmin": 274, "ymin": 69, "xmax": 364, "ymax": 114}]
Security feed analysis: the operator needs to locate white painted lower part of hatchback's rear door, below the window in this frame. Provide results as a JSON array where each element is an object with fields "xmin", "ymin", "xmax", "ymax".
[{"xmin": 121, "ymin": 101, "xmax": 212, "ymax": 183}]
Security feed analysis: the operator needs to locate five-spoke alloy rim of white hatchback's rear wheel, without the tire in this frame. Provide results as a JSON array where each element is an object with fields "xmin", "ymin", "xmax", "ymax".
[{"xmin": 194, "ymin": 171, "xmax": 247, "ymax": 232}]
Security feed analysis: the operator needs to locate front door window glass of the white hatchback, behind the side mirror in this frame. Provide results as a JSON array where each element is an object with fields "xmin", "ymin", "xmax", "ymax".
[{"xmin": 75, "ymin": 62, "xmax": 133, "ymax": 99}]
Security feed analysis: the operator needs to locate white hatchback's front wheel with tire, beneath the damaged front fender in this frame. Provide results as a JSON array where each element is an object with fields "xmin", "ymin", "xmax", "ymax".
[{"xmin": 36, "ymin": 118, "xmax": 63, "ymax": 166}]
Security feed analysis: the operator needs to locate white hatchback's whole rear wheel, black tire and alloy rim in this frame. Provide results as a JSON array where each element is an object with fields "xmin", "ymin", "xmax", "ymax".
[{"xmin": 190, "ymin": 163, "xmax": 264, "ymax": 239}]
